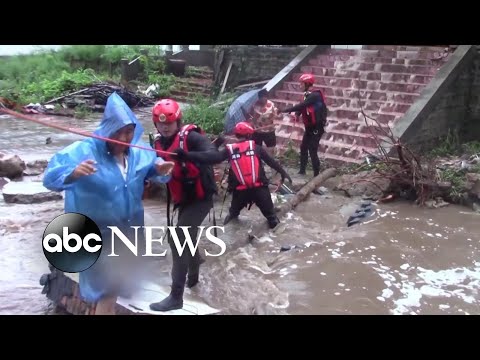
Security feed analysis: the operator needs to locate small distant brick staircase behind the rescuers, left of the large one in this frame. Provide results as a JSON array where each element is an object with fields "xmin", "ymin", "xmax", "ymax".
[{"xmin": 171, "ymin": 67, "xmax": 213, "ymax": 103}]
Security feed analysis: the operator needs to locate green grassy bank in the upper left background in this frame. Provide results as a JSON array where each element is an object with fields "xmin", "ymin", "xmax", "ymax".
[{"xmin": 0, "ymin": 45, "xmax": 169, "ymax": 105}]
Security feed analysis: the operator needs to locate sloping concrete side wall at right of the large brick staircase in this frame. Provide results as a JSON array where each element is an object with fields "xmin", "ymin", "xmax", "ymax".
[{"xmin": 393, "ymin": 45, "xmax": 480, "ymax": 151}]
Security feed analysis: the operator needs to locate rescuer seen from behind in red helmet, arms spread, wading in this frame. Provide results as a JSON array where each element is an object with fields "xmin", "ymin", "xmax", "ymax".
[{"xmin": 173, "ymin": 122, "xmax": 292, "ymax": 229}]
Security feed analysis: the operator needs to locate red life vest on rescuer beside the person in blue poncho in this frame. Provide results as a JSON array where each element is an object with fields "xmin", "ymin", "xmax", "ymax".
[{"xmin": 154, "ymin": 124, "xmax": 205, "ymax": 204}]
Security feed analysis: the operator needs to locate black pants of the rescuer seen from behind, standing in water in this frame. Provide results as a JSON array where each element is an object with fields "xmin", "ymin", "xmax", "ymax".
[{"xmin": 229, "ymin": 186, "xmax": 277, "ymax": 224}]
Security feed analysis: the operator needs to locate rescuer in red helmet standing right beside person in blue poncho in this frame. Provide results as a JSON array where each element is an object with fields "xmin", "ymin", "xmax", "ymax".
[{"xmin": 150, "ymin": 99, "xmax": 218, "ymax": 311}]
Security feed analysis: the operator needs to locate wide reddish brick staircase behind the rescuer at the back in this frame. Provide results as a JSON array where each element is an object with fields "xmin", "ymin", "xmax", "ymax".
[{"xmin": 270, "ymin": 45, "xmax": 451, "ymax": 163}]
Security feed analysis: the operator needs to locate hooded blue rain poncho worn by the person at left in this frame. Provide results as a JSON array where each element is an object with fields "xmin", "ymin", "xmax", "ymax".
[{"xmin": 43, "ymin": 93, "xmax": 170, "ymax": 302}]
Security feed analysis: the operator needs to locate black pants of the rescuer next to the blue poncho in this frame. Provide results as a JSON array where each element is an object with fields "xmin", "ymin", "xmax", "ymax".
[{"xmin": 169, "ymin": 198, "xmax": 213, "ymax": 295}]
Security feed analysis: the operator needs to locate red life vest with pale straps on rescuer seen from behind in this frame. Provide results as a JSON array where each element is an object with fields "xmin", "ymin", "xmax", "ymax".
[{"xmin": 227, "ymin": 140, "xmax": 263, "ymax": 190}]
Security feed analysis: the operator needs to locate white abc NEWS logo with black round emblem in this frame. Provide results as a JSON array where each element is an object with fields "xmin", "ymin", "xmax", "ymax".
[{"xmin": 42, "ymin": 213, "xmax": 226, "ymax": 273}]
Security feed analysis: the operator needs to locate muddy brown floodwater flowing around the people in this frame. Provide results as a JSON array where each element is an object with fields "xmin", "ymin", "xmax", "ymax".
[{"xmin": 0, "ymin": 113, "xmax": 480, "ymax": 315}]
